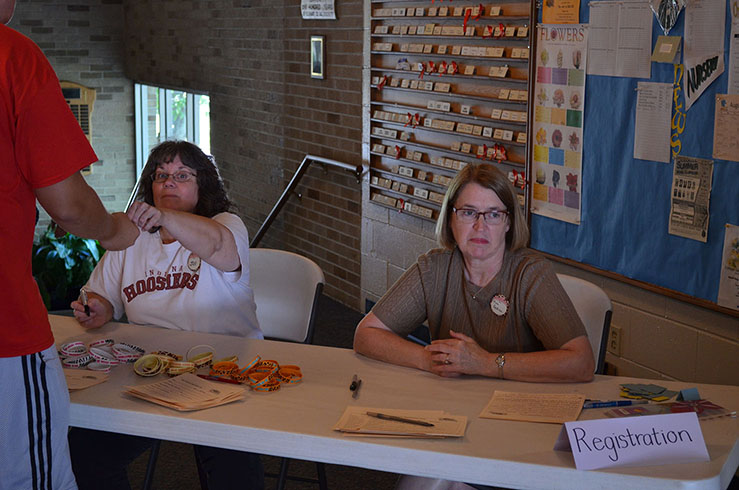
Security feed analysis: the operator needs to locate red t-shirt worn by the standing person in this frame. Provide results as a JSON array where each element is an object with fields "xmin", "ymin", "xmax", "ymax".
[{"xmin": 0, "ymin": 25, "xmax": 97, "ymax": 357}]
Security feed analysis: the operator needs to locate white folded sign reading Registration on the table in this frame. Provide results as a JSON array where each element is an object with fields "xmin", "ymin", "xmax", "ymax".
[{"xmin": 554, "ymin": 412, "xmax": 710, "ymax": 470}]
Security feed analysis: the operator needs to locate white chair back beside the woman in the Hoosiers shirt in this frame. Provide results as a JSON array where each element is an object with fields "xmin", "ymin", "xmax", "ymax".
[{"xmin": 249, "ymin": 248, "xmax": 325, "ymax": 344}]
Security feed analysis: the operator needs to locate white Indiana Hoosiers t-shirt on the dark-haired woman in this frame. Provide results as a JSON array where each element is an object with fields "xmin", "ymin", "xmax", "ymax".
[{"xmin": 87, "ymin": 213, "xmax": 263, "ymax": 338}]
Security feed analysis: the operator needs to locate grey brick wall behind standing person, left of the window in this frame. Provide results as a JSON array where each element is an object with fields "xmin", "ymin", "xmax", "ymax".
[{"xmin": 8, "ymin": 0, "xmax": 135, "ymax": 233}]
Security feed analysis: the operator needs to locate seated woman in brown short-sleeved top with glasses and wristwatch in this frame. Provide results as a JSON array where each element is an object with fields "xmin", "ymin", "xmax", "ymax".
[{"xmin": 354, "ymin": 164, "xmax": 594, "ymax": 382}]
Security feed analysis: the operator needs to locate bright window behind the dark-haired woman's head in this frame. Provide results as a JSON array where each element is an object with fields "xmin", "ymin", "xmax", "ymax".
[{"xmin": 134, "ymin": 83, "xmax": 210, "ymax": 176}]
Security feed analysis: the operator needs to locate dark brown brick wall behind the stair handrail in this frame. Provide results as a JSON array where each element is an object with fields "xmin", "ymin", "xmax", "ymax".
[{"xmin": 125, "ymin": 0, "xmax": 363, "ymax": 308}]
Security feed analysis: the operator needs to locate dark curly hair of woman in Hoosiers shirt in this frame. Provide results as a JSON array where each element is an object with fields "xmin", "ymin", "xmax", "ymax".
[{"xmin": 136, "ymin": 141, "xmax": 234, "ymax": 218}]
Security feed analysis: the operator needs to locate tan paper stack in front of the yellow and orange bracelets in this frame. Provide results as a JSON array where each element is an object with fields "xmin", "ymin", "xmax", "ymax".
[{"xmin": 126, "ymin": 373, "xmax": 244, "ymax": 412}]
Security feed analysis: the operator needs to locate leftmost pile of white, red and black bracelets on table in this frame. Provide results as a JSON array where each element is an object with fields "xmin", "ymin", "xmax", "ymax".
[{"xmin": 59, "ymin": 339, "xmax": 144, "ymax": 373}]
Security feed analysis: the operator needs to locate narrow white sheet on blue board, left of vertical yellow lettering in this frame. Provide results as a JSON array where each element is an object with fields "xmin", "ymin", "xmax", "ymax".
[{"xmin": 634, "ymin": 82, "xmax": 672, "ymax": 163}]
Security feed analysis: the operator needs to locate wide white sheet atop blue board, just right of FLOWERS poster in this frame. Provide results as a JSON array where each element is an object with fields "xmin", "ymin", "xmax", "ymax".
[{"xmin": 588, "ymin": 1, "xmax": 653, "ymax": 78}]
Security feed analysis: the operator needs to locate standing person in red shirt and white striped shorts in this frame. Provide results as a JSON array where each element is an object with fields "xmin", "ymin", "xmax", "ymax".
[{"xmin": 0, "ymin": 0, "xmax": 139, "ymax": 490}]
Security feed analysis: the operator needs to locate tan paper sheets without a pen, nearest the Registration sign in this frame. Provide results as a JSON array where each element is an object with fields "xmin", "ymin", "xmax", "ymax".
[{"xmin": 480, "ymin": 390, "xmax": 585, "ymax": 424}]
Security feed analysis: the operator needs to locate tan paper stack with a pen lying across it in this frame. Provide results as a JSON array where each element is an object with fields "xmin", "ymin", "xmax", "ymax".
[{"xmin": 334, "ymin": 406, "xmax": 467, "ymax": 437}]
